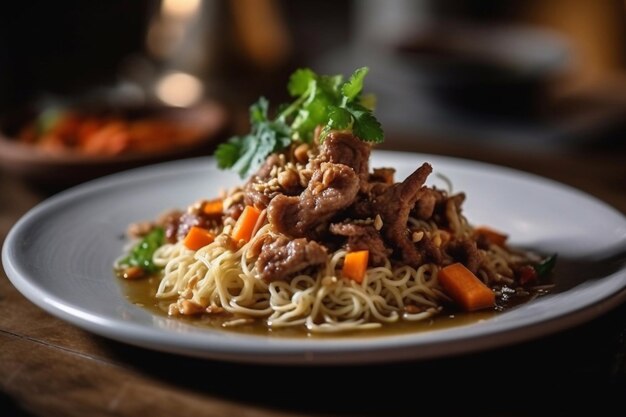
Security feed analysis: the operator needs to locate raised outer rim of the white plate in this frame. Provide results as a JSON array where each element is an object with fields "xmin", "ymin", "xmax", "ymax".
[{"xmin": 2, "ymin": 150, "xmax": 626, "ymax": 364}]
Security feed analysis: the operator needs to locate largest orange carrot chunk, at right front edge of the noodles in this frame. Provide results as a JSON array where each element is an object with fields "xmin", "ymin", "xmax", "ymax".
[{"xmin": 438, "ymin": 262, "xmax": 496, "ymax": 311}]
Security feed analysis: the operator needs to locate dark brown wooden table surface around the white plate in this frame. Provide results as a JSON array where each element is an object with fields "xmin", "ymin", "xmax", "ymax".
[{"xmin": 0, "ymin": 137, "xmax": 626, "ymax": 417}]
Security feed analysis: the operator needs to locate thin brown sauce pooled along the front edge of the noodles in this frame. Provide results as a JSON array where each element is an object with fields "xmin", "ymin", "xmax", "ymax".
[{"xmin": 116, "ymin": 276, "xmax": 541, "ymax": 338}]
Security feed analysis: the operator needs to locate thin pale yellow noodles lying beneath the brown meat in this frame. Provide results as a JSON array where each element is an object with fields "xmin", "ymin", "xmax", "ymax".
[{"xmin": 147, "ymin": 204, "xmax": 532, "ymax": 332}]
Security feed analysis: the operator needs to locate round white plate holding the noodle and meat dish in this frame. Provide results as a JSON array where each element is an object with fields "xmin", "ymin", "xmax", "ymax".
[{"xmin": 2, "ymin": 152, "xmax": 626, "ymax": 364}]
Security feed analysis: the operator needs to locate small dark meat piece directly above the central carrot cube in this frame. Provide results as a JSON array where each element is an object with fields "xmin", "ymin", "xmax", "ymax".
[{"xmin": 330, "ymin": 223, "xmax": 391, "ymax": 266}]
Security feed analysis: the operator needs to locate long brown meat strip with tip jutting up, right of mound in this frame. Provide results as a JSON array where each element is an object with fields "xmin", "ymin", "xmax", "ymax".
[{"xmin": 372, "ymin": 163, "xmax": 432, "ymax": 267}]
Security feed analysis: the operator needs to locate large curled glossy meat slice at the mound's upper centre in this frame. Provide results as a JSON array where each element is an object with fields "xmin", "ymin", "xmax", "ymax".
[{"xmin": 267, "ymin": 162, "xmax": 359, "ymax": 239}]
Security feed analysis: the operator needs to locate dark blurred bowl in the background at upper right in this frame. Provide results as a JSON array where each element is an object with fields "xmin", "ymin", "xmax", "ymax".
[{"xmin": 396, "ymin": 23, "xmax": 571, "ymax": 116}]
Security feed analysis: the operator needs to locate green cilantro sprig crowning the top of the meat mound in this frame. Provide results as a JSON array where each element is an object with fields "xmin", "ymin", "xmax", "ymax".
[{"xmin": 215, "ymin": 67, "xmax": 384, "ymax": 178}]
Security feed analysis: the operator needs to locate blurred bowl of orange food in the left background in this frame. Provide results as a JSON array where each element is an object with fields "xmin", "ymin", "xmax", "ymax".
[{"xmin": 0, "ymin": 97, "xmax": 229, "ymax": 187}]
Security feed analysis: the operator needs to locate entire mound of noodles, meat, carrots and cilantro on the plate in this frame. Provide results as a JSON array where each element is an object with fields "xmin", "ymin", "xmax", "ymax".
[{"xmin": 115, "ymin": 68, "xmax": 556, "ymax": 332}]
